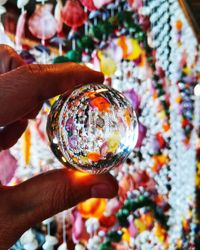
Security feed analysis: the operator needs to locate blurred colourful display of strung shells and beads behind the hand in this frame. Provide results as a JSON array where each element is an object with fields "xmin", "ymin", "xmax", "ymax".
[{"xmin": 0, "ymin": 0, "xmax": 200, "ymax": 250}]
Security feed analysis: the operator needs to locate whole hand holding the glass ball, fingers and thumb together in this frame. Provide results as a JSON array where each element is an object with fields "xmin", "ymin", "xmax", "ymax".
[{"xmin": 0, "ymin": 45, "xmax": 118, "ymax": 250}]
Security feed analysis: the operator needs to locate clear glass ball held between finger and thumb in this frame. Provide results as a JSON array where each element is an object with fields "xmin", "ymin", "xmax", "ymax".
[{"xmin": 47, "ymin": 84, "xmax": 138, "ymax": 174}]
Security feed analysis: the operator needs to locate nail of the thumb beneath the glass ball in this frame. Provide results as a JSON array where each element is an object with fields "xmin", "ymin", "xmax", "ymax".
[{"xmin": 91, "ymin": 183, "xmax": 117, "ymax": 198}]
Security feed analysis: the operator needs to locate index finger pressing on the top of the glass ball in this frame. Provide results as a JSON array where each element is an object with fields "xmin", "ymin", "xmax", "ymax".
[{"xmin": 0, "ymin": 63, "xmax": 104, "ymax": 126}]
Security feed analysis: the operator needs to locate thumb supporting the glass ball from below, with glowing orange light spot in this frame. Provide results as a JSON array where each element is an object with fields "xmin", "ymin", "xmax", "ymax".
[{"xmin": 2, "ymin": 169, "xmax": 118, "ymax": 247}]
